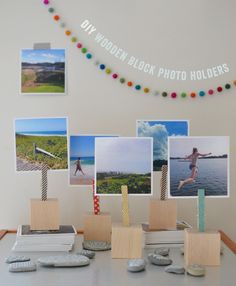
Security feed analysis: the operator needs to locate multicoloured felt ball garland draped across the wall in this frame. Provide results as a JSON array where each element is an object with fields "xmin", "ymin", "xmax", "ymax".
[{"xmin": 43, "ymin": 0, "xmax": 236, "ymax": 99}]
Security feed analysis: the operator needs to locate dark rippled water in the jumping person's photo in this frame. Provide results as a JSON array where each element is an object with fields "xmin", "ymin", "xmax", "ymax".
[{"xmin": 169, "ymin": 158, "xmax": 228, "ymax": 196}]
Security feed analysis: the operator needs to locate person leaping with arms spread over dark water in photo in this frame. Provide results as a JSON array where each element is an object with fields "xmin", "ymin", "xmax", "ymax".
[{"xmin": 178, "ymin": 147, "xmax": 211, "ymax": 190}]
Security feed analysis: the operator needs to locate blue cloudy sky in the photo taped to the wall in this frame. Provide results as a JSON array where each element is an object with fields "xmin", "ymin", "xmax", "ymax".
[{"xmin": 21, "ymin": 49, "xmax": 65, "ymax": 64}]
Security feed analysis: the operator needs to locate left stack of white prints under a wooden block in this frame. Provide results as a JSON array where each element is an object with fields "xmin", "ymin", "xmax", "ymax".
[{"xmin": 12, "ymin": 225, "xmax": 77, "ymax": 251}]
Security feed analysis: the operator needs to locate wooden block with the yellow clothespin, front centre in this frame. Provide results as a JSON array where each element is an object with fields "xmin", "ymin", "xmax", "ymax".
[{"xmin": 111, "ymin": 225, "xmax": 143, "ymax": 259}]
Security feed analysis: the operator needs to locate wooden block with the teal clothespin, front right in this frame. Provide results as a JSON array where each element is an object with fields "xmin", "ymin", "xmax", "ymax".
[{"xmin": 184, "ymin": 229, "xmax": 220, "ymax": 266}]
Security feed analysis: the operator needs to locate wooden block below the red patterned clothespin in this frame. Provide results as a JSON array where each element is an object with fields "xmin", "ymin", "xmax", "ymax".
[{"xmin": 84, "ymin": 213, "xmax": 111, "ymax": 242}]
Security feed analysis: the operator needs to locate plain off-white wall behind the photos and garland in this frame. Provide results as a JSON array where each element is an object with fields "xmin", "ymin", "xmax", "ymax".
[{"xmin": 0, "ymin": 0, "xmax": 236, "ymax": 239}]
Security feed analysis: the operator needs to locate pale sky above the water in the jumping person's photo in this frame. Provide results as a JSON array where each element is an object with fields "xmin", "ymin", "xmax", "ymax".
[{"xmin": 169, "ymin": 136, "xmax": 229, "ymax": 158}]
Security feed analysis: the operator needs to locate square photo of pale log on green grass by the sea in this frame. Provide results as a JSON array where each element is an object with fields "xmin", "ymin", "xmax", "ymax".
[{"xmin": 15, "ymin": 117, "xmax": 68, "ymax": 171}]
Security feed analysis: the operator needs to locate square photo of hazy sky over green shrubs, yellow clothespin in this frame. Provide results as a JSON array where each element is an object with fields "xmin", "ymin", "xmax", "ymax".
[{"xmin": 95, "ymin": 137, "xmax": 153, "ymax": 195}]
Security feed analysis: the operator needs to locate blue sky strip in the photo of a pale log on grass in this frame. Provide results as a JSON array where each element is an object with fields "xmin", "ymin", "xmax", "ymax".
[{"xmin": 15, "ymin": 118, "xmax": 67, "ymax": 133}]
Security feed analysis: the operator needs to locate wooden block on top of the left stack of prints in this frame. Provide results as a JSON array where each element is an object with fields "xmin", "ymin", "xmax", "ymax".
[{"xmin": 30, "ymin": 199, "xmax": 59, "ymax": 230}]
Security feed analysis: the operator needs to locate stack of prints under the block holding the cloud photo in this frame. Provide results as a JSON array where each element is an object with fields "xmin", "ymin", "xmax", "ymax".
[{"xmin": 142, "ymin": 221, "xmax": 191, "ymax": 248}]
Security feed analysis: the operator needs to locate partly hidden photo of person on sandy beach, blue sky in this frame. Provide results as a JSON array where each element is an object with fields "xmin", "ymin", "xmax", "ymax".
[{"xmin": 69, "ymin": 135, "xmax": 116, "ymax": 186}]
